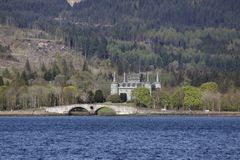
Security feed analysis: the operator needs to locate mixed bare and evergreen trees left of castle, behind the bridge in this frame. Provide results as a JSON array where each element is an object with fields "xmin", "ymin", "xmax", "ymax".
[{"xmin": 0, "ymin": 57, "xmax": 111, "ymax": 110}]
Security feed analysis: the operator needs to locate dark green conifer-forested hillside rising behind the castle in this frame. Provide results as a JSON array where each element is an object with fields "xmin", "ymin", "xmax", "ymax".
[{"xmin": 0, "ymin": 0, "xmax": 240, "ymax": 110}]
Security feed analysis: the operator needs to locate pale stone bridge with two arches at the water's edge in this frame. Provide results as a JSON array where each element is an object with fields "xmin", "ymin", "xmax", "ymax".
[{"xmin": 45, "ymin": 104, "xmax": 137, "ymax": 115}]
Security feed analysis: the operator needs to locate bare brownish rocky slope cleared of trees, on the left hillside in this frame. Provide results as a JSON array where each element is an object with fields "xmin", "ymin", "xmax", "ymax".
[{"xmin": 0, "ymin": 26, "xmax": 82, "ymax": 69}]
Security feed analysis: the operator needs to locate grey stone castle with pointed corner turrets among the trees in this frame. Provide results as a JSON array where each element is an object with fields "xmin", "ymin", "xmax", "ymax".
[{"xmin": 111, "ymin": 73, "xmax": 161, "ymax": 101}]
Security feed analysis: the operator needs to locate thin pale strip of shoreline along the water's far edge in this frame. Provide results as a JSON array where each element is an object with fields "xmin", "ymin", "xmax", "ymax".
[{"xmin": 0, "ymin": 109, "xmax": 240, "ymax": 117}]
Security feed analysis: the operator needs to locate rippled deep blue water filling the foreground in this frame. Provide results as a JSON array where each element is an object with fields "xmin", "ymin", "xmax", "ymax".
[{"xmin": 0, "ymin": 116, "xmax": 240, "ymax": 160}]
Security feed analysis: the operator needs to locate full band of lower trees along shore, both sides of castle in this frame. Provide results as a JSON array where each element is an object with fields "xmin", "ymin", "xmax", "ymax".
[{"xmin": 0, "ymin": 58, "xmax": 240, "ymax": 111}]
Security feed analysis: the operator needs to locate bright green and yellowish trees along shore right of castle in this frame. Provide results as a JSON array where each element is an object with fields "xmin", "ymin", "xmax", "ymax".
[{"xmin": 133, "ymin": 82, "xmax": 240, "ymax": 112}]
